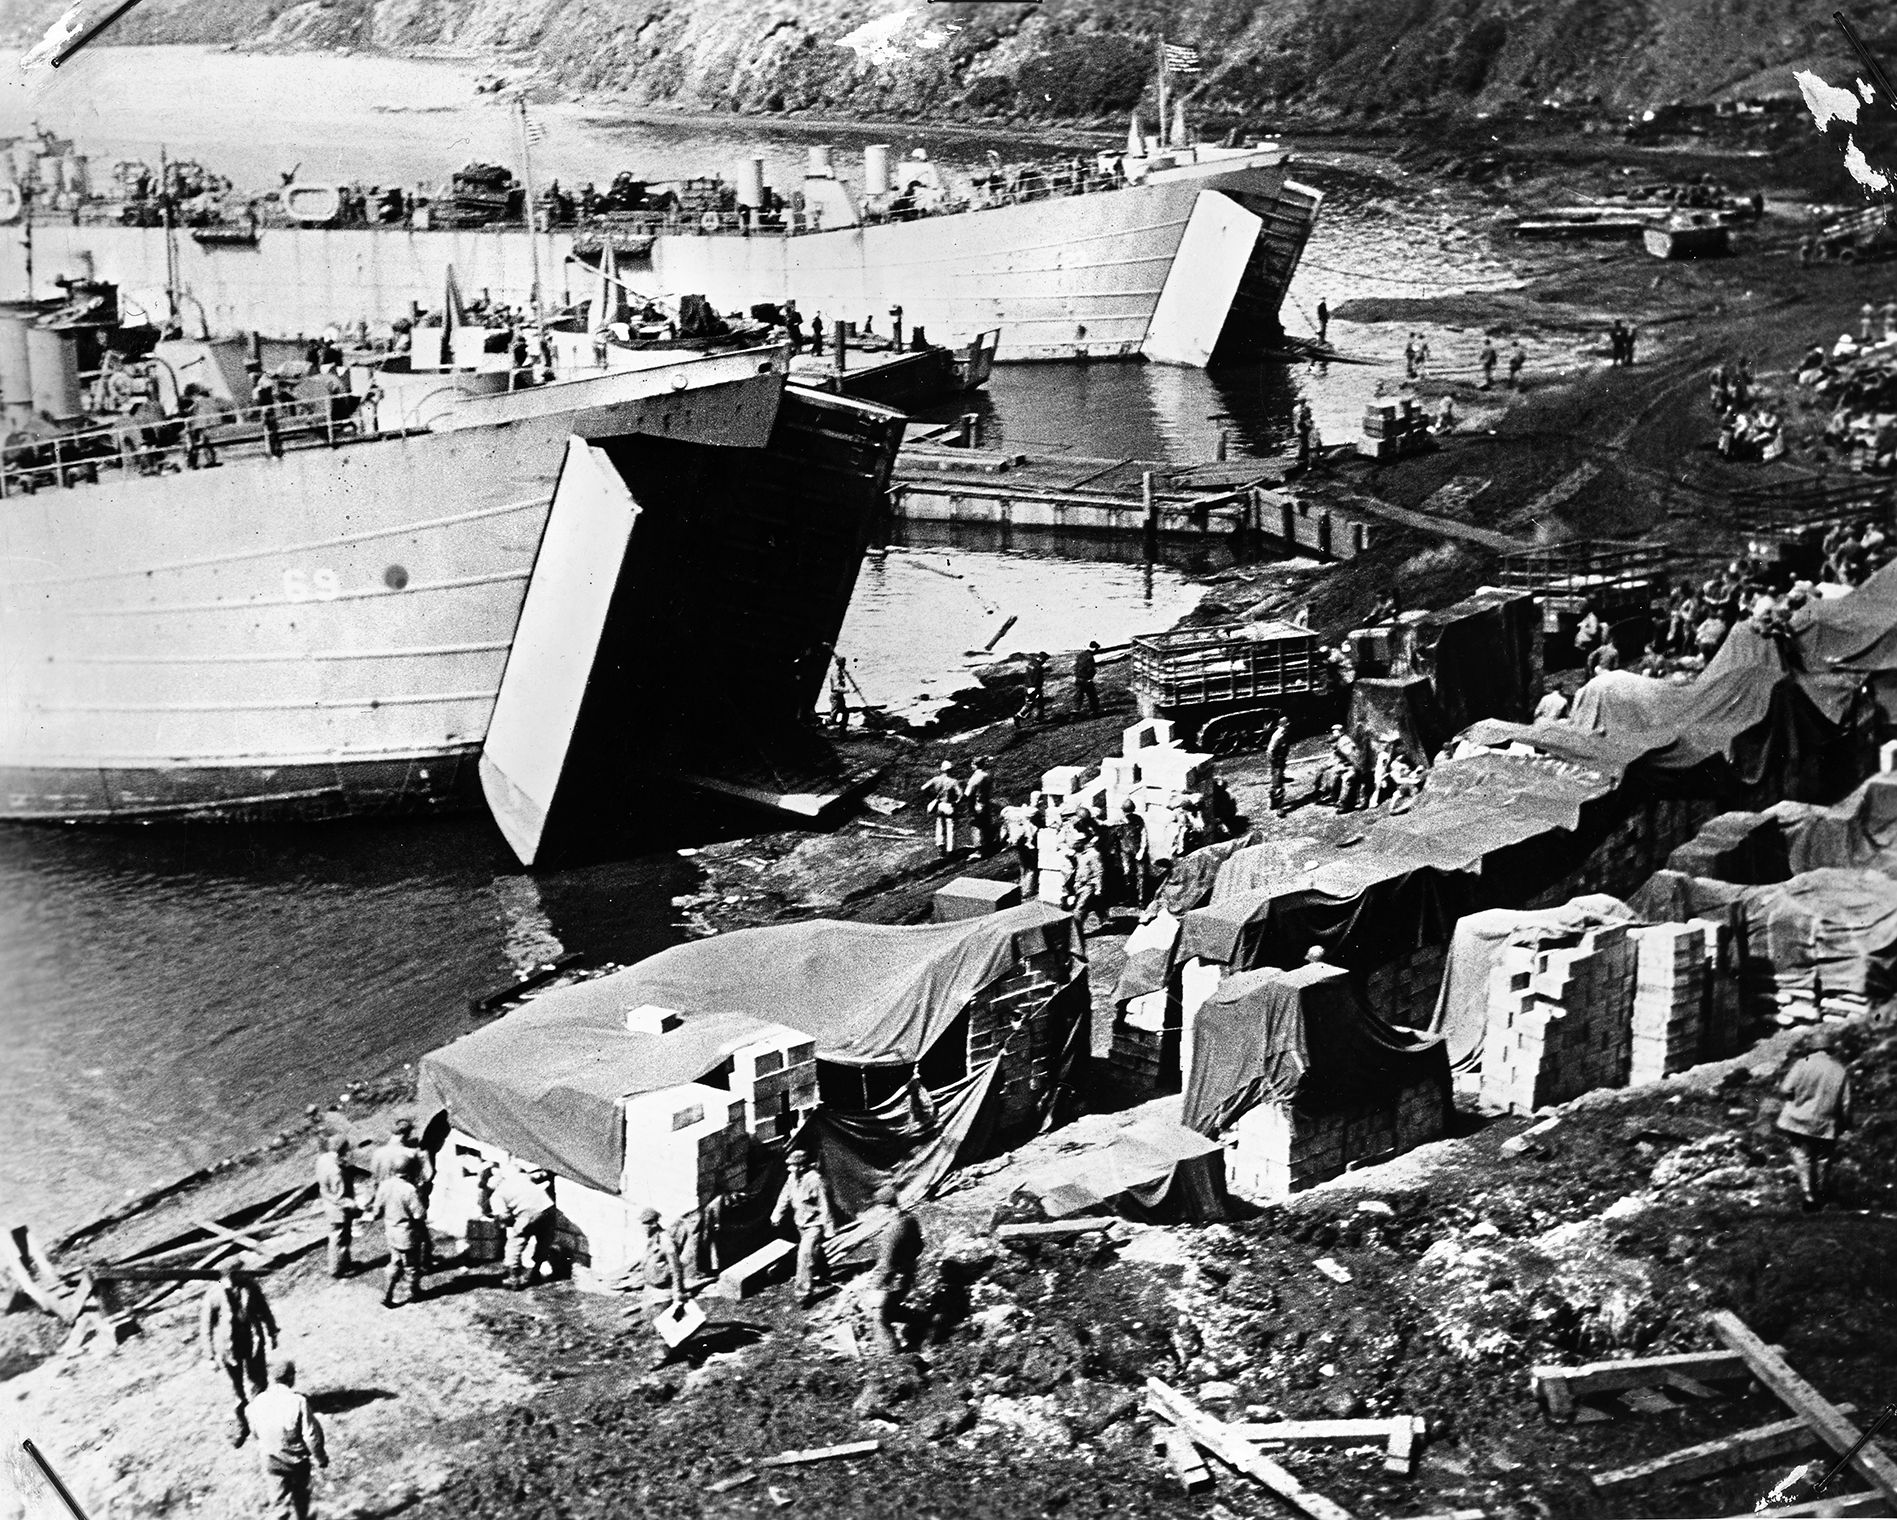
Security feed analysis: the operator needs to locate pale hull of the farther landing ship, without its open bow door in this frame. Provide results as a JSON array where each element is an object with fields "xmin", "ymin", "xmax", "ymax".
[{"xmin": 0, "ymin": 150, "xmax": 1317, "ymax": 362}]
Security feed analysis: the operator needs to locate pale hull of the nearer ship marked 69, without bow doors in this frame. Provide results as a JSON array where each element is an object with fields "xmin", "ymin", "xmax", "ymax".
[{"xmin": 0, "ymin": 351, "xmax": 872, "ymax": 822}]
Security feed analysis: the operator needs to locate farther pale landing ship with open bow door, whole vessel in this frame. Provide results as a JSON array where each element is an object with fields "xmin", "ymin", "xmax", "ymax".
[{"xmin": 0, "ymin": 137, "xmax": 1322, "ymax": 364}]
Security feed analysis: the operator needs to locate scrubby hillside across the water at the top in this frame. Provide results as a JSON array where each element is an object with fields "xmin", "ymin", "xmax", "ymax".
[{"xmin": 29, "ymin": 0, "xmax": 1897, "ymax": 120}]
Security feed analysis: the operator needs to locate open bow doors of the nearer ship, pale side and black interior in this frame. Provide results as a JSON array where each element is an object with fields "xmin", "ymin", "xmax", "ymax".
[{"xmin": 480, "ymin": 385, "xmax": 905, "ymax": 865}]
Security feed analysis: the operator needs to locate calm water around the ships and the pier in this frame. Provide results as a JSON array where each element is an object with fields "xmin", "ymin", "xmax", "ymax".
[{"xmin": 0, "ymin": 47, "xmax": 1501, "ymax": 1232}]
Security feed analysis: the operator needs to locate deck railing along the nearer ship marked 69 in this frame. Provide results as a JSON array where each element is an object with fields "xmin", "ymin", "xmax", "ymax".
[{"xmin": 0, "ymin": 393, "xmax": 376, "ymax": 497}]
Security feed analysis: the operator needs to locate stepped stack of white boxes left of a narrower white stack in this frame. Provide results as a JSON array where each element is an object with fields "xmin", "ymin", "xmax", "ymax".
[{"xmin": 1482, "ymin": 924, "xmax": 1637, "ymax": 1114}]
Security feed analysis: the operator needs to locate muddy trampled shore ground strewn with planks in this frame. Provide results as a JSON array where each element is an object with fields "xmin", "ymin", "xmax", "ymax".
[{"xmin": 11, "ymin": 112, "xmax": 1897, "ymax": 1520}]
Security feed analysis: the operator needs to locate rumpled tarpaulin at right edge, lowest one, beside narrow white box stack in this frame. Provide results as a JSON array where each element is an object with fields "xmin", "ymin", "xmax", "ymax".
[{"xmin": 1630, "ymin": 867, "xmax": 1897, "ymax": 1000}]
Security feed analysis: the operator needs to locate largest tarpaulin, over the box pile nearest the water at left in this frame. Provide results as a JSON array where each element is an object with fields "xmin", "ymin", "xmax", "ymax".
[{"xmin": 421, "ymin": 901, "xmax": 1072, "ymax": 1192}]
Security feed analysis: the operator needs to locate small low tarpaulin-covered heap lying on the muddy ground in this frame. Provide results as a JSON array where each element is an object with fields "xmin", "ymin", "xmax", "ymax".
[{"xmin": 1017, "ymin": 1118, "xmax": 1227, "ymax": 1222}]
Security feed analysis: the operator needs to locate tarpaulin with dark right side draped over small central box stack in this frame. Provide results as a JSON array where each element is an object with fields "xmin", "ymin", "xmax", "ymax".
[{"xmin": 1182, "ymin": 966, "xmax": 1449, "ymax": 1135}]
